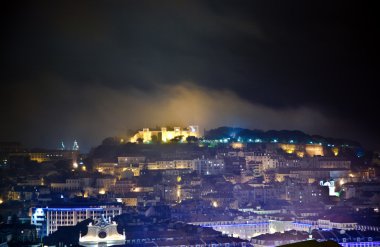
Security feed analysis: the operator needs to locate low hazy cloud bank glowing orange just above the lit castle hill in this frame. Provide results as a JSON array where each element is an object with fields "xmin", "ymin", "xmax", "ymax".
[{"xmin": 3, "ymin": 78, "xmax": 342, "ymax": 151}]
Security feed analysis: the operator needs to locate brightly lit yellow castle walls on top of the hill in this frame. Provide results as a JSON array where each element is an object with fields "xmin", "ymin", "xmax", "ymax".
[{"xmin": 130, "ymin": 125, "xmax": 200, "ymax": 143}]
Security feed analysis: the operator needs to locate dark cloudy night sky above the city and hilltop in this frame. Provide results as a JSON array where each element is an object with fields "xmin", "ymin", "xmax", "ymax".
[{"xmin": 0, "ymin": 0, "xmax": 380, "ymax": 151}]
